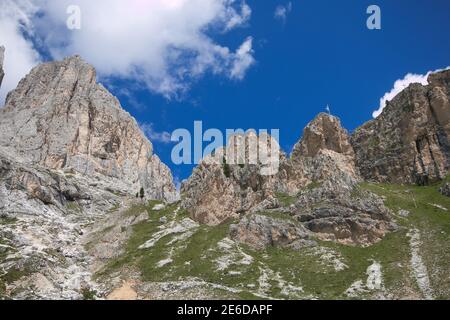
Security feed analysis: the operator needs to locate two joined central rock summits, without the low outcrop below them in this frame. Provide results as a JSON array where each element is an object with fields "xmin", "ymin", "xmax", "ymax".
[{"xmin": 181, "ymin": 114, "xmax": 358, "ymax": 225}]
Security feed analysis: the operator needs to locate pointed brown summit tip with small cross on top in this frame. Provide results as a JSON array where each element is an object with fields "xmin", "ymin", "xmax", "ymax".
[{"xmin": 292, "ymin": 113, "xmax": 354, "ymax": 159}]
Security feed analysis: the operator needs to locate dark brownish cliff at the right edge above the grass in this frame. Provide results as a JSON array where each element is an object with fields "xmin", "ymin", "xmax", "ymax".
[{"xmin": 352, "ymin": 70, "xmax": 450, "ymax": 185}]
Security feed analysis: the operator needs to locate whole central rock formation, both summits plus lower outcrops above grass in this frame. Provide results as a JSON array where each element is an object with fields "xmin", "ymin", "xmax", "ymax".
[{"xmin": 182, "ymin": 113, "xmax": 395, "ymax": 248}]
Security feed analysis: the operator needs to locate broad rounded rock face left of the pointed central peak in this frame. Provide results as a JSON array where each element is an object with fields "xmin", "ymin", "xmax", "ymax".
[{"xmin": 181, "ymin": 133, "xmax": 283, "ymax": 225}]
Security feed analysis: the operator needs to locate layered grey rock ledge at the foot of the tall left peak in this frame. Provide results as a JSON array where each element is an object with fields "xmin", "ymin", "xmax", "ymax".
[{"xmin": 0, "ymin": 150, "xmax": 121, "ymax": 217}]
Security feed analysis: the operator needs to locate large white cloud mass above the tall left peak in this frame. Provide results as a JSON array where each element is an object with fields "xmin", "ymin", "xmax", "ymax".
[{"xmin": 0, "ymin": 0, "xmax": 253, "ymax": 97}]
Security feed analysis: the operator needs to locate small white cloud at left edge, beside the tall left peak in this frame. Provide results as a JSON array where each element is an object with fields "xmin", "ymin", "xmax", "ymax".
[{"xmin": 0, "ymin": 0, "xmax": 39, "ymax": 106}]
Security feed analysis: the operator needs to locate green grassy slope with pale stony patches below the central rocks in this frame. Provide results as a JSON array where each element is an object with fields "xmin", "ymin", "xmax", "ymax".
[{"xmin": 96, "ymin": 179, "xmax": 450, "ymax": 299}]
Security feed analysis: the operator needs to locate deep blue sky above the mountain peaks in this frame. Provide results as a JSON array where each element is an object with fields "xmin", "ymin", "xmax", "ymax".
[{"xmin": 0, "ymin": 0, "xmax": 450, "ymax": 185}]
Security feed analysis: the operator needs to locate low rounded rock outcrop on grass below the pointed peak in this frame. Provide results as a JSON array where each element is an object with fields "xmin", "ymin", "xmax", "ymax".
[{"xmin": 298, "ymin": 181, "xmax": 397, "ymax": 245}]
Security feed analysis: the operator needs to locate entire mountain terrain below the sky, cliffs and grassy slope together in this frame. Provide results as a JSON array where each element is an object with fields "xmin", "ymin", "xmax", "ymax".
[{"xmin": 0, "ymin": 50, "xmax": 450, "ymax": 300}]
